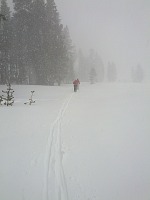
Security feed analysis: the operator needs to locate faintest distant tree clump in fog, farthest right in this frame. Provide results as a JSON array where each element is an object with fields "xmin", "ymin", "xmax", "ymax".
[{"xmin": 131, "ymin": 64, "xmax": 144, "ymax": 82}]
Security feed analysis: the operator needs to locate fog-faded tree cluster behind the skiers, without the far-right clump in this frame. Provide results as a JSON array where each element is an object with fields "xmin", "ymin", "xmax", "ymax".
[{"xmin": 76, "ymin": 49, "xmax": 117, "ymax": 84}]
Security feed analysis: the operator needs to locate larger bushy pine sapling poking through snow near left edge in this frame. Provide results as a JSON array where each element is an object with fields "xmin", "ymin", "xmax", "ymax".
[{"xmin": 2, "ymin": 83, "xmax": 14, "ymax": 106}]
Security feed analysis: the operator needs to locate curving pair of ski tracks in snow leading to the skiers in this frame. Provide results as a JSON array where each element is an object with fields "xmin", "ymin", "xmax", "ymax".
[{"xmin": 43, "ymin": 93, "xmax": 74, "ymax": 200}]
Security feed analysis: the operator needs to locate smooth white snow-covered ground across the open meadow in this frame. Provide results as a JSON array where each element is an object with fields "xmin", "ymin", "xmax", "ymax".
[{"xmin": 0, "ymin": 83, "xmax": 150, "ymax": 200}]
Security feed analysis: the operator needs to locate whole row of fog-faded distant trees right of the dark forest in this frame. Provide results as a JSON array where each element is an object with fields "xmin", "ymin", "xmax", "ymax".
[{"xmin": 75, "ymin": 49, "xmax": 144, "ymax": 84}]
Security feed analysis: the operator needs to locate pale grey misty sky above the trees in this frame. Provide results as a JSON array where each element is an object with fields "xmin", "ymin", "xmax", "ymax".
[{"xmin": 8, "ymin": 0, "xmax": 150, "ymax": 79}]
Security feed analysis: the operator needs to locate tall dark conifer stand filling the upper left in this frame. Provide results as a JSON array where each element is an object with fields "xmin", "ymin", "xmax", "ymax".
[{"xmin": 0, "ymin": 0, "xmax": 75, "ymax": 85}]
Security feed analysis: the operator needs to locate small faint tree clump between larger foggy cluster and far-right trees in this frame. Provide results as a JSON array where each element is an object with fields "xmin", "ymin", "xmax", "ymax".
[{"xmin": 107, "ymin": 63, "xmax": 117, "ymax": 82}]
